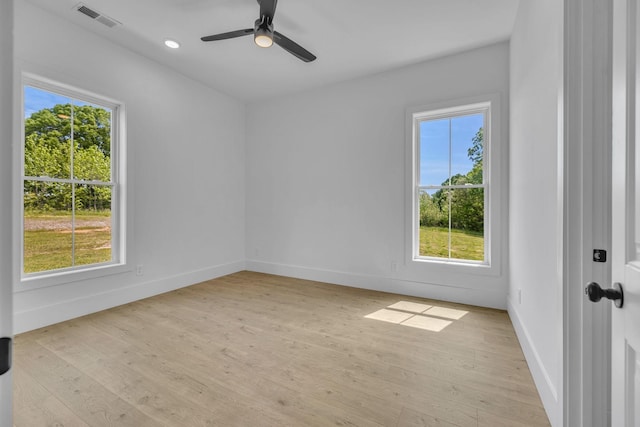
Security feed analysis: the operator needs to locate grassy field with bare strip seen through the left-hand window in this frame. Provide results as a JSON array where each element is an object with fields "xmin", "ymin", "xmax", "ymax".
[{"xmin": 24, "ymin": 212, "xmax": 111, "ymax": 273}]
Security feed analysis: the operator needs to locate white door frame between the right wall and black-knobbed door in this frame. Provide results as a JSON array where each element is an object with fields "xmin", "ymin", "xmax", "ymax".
[{"xmin": 559, "ymin": 0, "xmax": 612, "ymax": 427}]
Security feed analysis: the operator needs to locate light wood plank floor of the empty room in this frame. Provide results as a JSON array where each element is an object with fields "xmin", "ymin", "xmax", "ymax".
[{"xmin": 14, "ymin": 272, "xmax": 549, "ymax": 427}]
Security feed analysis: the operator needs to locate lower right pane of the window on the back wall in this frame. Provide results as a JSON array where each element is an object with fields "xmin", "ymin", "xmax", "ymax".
[{"xmin": 451, "ymin": 188, "xmax": 484, "ymax": 261}]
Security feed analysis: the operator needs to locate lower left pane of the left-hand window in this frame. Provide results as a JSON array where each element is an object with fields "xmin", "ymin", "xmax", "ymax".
[{"xmin": 24, "ymin": 181, "xmax": 73, "ymax": 273}]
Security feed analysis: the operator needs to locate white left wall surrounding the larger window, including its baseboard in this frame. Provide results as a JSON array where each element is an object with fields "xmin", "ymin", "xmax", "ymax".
[{"xmin": 13, "ymin": 1, "xmax": 245, "ymax": 332}]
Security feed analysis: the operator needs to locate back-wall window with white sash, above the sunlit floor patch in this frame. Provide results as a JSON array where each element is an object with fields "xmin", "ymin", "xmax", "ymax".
[{"xmin": 411, "ymin": 102, "xmax": 491, "ymax": 265}]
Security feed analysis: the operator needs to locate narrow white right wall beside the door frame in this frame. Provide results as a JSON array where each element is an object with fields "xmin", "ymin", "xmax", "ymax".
[{"xmin": 509, "ymin": 0, "xmax": 563, "ymax": 426}]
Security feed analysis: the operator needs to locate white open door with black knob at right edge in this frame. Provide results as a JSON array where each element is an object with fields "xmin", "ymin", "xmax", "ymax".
[{"xmin": 608, "ymin": 0, "xmax": 640, "ymax": 427}]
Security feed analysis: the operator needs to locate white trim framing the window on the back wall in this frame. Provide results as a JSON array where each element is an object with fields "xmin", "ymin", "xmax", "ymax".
[{"xmin": 405, "ymin": 94, "xmax": 507, "ymax": 276}]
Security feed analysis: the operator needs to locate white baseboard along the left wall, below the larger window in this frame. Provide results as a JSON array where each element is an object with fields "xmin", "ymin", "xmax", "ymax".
[{"xmin": 13, "ymin": 261, "xmax": 245, "ymax": 334}]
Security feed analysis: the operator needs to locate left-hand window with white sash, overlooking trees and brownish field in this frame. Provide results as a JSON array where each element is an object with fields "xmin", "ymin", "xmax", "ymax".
[{"xmin": 22, "ymin": 77, "xmax": 124, "ymax": 279}]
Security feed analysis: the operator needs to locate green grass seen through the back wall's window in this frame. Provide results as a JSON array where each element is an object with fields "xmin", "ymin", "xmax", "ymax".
[{"xmin": 420, "ymin": 227, "xmax": 484, "ymax": 261}]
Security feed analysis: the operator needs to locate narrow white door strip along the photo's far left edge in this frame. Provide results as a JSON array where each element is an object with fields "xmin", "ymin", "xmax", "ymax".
[{"xmin": 0, "ymin": 0, "xmax": 13, "ymax": 427}]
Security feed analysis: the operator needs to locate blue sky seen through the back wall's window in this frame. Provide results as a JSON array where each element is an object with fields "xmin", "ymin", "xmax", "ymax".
[{"xmin": 420, "ymin": 114, "xmax": 484, "ymax": 185}]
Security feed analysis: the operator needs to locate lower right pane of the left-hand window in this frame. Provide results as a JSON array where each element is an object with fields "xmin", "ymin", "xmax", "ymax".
[{"xmin": 75, "ymin": 185, "xmax": 111, "ymax": 265}]
